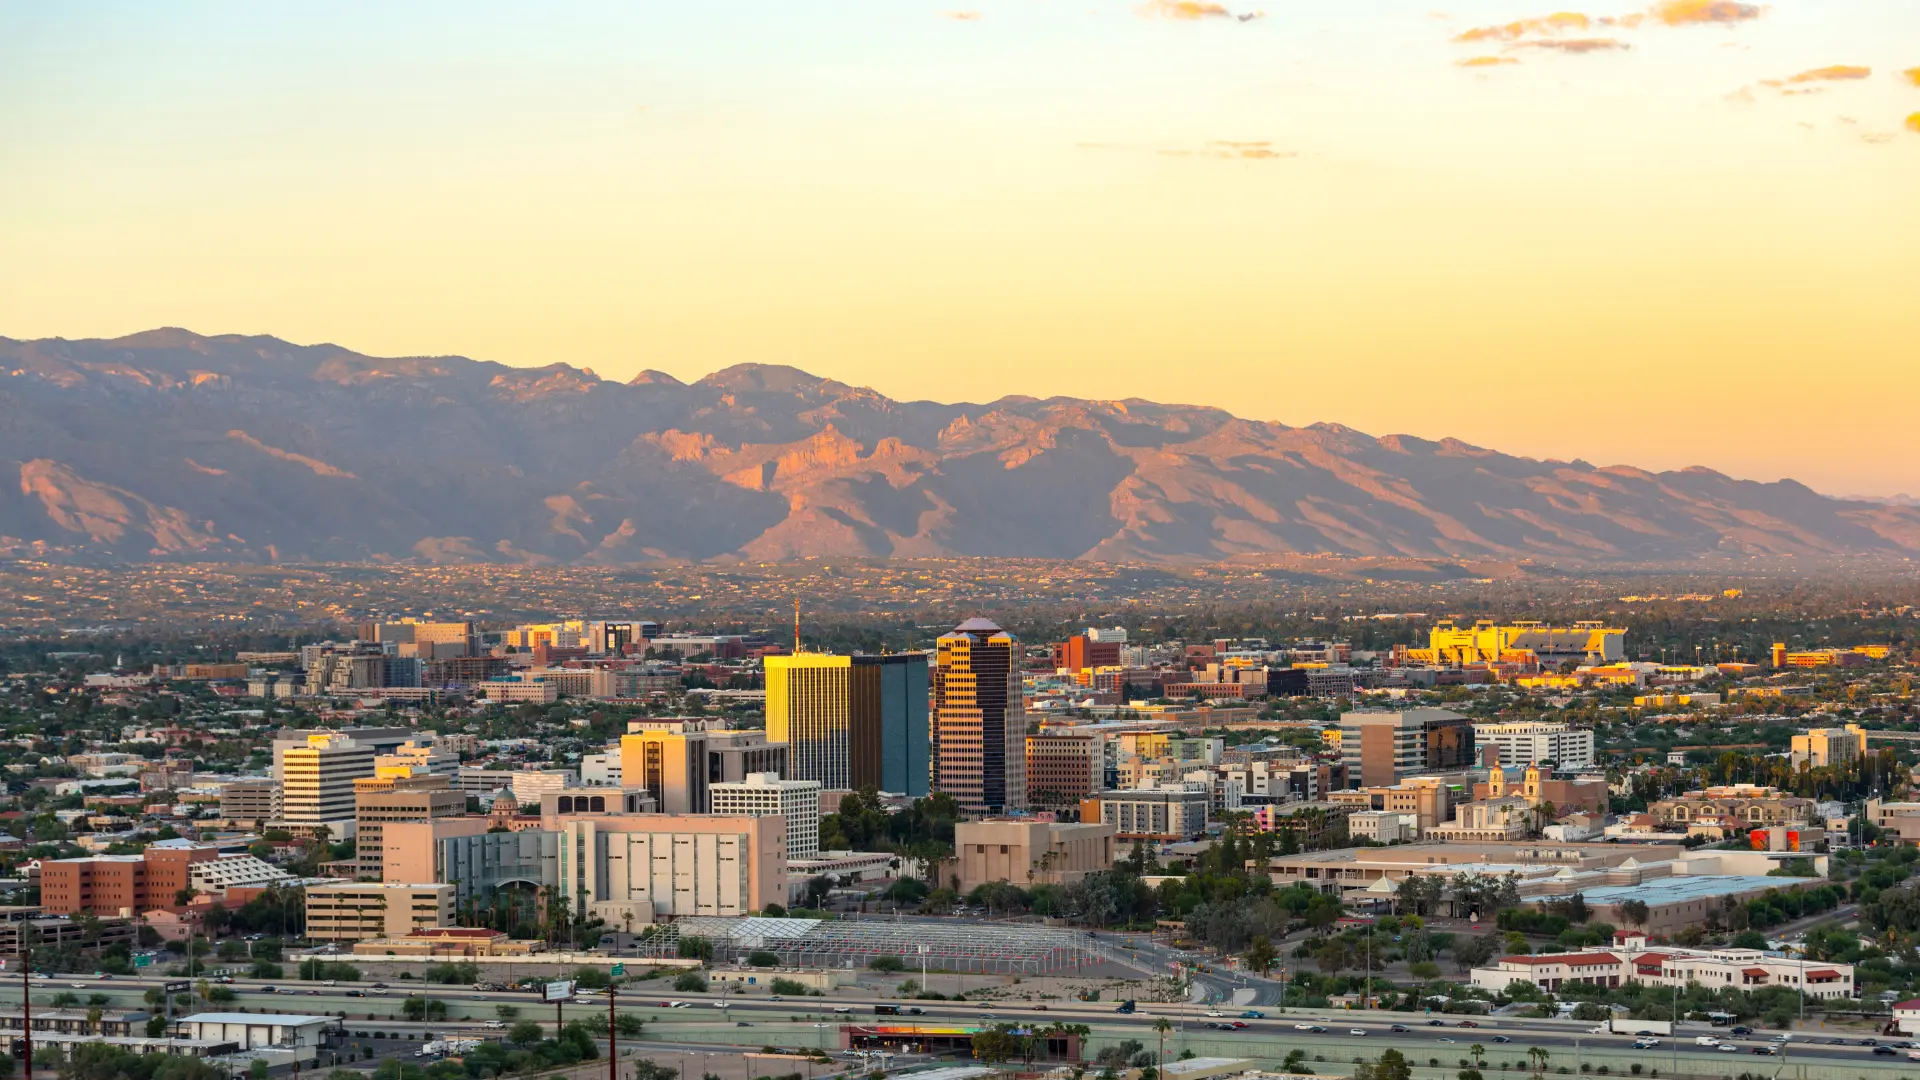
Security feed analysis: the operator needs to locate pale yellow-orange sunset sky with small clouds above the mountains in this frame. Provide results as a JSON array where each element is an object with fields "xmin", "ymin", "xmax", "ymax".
[{"xmin": 0, "ymin": 0, "xmax": 1920, "ymax": 494}]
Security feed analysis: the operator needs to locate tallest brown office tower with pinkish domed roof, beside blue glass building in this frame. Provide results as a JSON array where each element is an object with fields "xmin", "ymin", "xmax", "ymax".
[{"xmin": 933, "ymin": 619, "xmax": 1027, "ymax": 815}]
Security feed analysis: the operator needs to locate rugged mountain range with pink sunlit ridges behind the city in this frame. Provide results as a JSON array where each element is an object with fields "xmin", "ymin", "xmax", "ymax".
[{"xmin": 0, "ymin": 329, "xmax": 1920, "ymax": 565}]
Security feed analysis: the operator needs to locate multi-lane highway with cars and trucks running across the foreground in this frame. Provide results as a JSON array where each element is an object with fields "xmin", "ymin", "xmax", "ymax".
[{"xmin": 18, "ymin": 976, "xmax": 1910, "ymax": 1076}]
